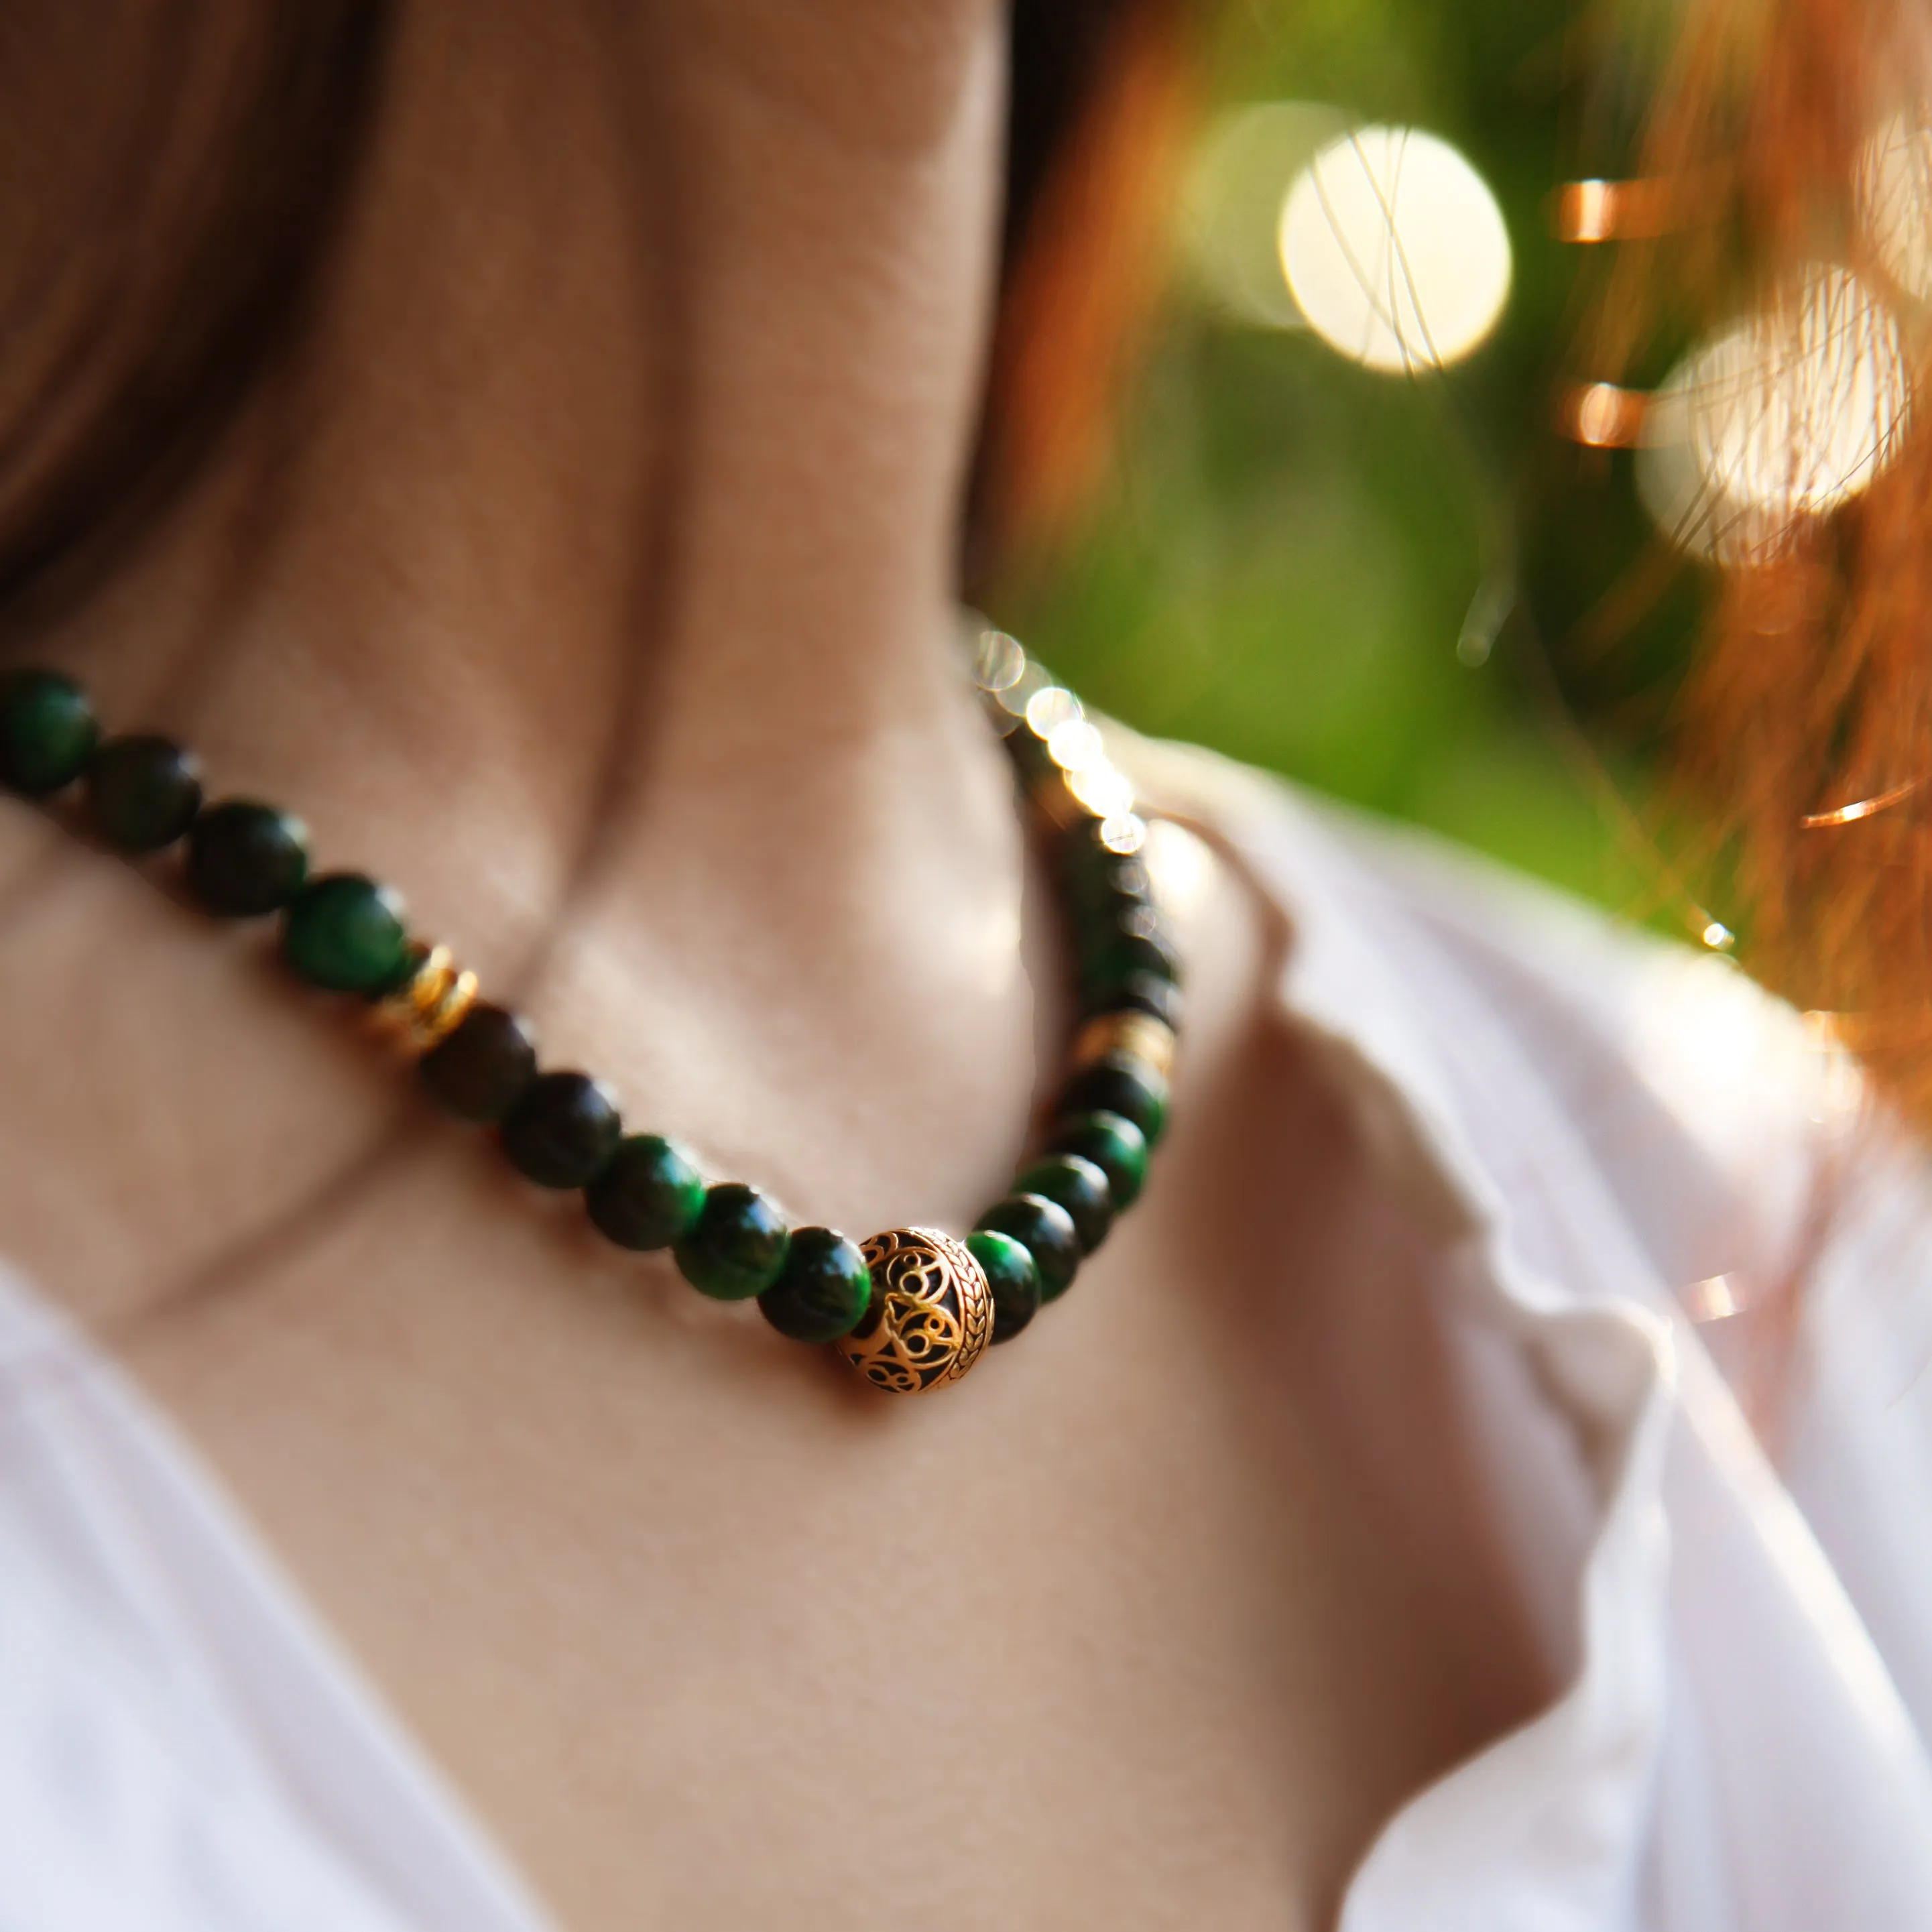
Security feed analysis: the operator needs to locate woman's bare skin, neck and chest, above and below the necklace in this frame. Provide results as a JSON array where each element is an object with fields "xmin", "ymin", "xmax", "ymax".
[{"xmin": 0, "ymin": 0, "xmax": 1547, "ymax": 1932}]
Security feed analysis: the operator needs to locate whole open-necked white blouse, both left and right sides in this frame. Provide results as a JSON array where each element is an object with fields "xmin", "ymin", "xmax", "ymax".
[{"xmin": 11, "ymin": 745, "xmax": 1932, "ymax": 1932}]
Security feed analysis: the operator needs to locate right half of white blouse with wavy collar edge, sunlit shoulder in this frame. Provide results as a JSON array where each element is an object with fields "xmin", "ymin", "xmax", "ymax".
[{"xmin": 1117, "ymin": 744, "xmax": 1932, "ymax": 1928}]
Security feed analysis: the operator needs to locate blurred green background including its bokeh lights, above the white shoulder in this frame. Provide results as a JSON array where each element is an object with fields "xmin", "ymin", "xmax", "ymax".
[{"xmin": 970, "ymin": 0, "xmax": 1926, "ymax": 951}]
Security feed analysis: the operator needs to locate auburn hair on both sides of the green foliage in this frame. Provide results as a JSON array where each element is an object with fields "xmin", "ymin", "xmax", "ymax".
[{"xmin": 981, "ymin": 0, "xmax": 1932, "ymax": 1122}]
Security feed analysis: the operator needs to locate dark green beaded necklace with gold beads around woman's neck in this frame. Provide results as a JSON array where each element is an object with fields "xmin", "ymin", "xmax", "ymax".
[{"xmin": 0, "ymin": 630, "xmax": 1181, "ymax": 1395}]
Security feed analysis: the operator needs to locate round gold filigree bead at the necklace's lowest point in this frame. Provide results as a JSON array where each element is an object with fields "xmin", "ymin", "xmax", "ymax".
[{"xmin": 833, "ymin": 1227, "xmax": 993, "ymax": 1395}]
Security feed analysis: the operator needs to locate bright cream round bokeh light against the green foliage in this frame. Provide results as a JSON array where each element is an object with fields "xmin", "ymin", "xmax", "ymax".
[{"xmin": 1281, "ymin": 127, "xmax": 1511, "ymax": 375}]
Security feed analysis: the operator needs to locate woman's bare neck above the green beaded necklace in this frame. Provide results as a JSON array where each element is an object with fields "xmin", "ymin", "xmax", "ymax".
[{"xmin": 8, "ymin": 0, "xmax": 1053, "ymax": 1302}]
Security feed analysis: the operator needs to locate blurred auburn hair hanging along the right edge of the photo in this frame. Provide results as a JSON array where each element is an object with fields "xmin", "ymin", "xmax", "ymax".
[{"xmin": 1586, "ymin": 0, "xmax": 1932, "ymax": 1122}]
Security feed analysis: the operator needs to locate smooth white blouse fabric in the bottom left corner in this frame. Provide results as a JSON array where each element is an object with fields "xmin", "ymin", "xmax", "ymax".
[{"xmin": 0, "ymin": 1244, "xmax": 545, "ymax": 1932}]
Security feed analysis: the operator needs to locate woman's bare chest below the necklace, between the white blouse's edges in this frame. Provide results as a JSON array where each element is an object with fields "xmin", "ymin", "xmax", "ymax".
[{"xmin": 121, "ymin": 1065, "xmax": 1547, "ymax": 1932}]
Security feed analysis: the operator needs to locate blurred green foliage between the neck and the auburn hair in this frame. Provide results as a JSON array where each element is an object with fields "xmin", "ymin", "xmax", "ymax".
[{"xmin": 985, "ymin": 0, "xmax": 1698, "ymax": 931}]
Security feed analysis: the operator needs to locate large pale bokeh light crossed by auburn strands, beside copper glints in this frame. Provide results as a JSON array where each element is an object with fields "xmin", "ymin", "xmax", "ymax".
[{"xmin": 1636, "ymin": 267, "xmax": 1911, "ymax": 564}]
